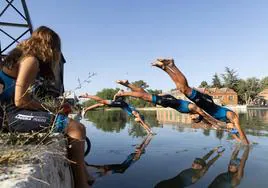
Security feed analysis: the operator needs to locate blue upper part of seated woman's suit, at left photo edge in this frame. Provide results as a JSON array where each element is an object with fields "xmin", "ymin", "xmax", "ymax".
[{"xmin": 0, "ymin": 70, "xmax": 16, "ymax": 102}]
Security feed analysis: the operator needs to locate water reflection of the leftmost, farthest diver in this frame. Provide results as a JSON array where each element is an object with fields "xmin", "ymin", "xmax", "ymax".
[{"xmin": 87, "ymin": 134, "xmax": 153, "ymax": 178}]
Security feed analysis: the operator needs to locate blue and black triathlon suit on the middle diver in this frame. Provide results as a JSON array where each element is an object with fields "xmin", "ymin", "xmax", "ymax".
[{"xmin": 152, "ymin": 95, "xmax": 191, "ymax": 113}]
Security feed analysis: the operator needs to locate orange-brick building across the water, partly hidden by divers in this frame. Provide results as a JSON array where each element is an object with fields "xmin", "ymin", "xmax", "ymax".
[{"xmin": 166, "ymin": 88, "xmax": 238, "ymax": 105}]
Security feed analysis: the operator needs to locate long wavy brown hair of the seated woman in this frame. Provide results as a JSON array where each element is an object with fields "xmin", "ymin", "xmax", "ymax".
[{"xmin": 3, "ymin": 26, "xmax": 61, "ymax": 77}]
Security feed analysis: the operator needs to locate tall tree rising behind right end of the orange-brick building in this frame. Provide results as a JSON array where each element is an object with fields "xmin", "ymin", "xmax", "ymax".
[{"xmin": 221, "ymin": 67, "xmax": 239, "ymax": 91}]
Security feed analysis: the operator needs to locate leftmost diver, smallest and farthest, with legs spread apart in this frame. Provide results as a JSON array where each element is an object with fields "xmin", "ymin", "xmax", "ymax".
[{"xmin": 79, "ymin": 93, "xmax": 154, "ymax": 134}]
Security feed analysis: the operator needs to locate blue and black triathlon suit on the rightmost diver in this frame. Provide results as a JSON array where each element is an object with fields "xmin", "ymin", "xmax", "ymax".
[{"xmin": 187, "ymin": 89, "xmax": 231, "ymax": 123}]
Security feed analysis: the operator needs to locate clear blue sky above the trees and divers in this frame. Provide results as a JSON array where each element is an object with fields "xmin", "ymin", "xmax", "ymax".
[{"xmin": 1, "ymin": 0, "xmax": 268, "ymax": 94}]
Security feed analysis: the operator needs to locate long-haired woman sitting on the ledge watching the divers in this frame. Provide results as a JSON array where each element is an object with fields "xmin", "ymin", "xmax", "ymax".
[{"xmin": 0, "ymin": 26, "xmax": 89, "ymax": 188}]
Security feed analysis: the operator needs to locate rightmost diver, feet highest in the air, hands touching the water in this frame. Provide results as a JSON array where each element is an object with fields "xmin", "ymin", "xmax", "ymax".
[{"xmin": 152, "ymin": 59, "xmax": 249, "ymax": 145}]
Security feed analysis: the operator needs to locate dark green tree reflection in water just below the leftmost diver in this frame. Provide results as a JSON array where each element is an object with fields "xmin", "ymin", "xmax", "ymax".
[{"xmin": 86, "ymin": 110, "xmax": 127, "ymax": 132}]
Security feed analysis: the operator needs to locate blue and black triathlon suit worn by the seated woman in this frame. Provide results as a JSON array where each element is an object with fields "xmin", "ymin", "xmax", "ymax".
[{"xmin": 0, "ymin": 70, "xmax": 69, "ymax": 132}]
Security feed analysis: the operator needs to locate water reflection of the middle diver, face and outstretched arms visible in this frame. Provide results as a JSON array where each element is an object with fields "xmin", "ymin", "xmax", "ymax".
[{"xmin": 155, "ymin": 146, "xmax": 224, "ymax": 188}]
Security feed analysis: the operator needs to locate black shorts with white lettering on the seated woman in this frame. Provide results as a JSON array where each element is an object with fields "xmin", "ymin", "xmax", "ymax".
[{"xmin": 6, "ymin": 106, "xmax": 55, "ymax": 132}]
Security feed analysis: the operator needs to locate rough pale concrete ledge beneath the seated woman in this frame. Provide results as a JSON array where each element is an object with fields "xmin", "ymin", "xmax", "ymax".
[{"xmin": 0, "ymin": 135, "xmax": 74, "ymax": 188}]
